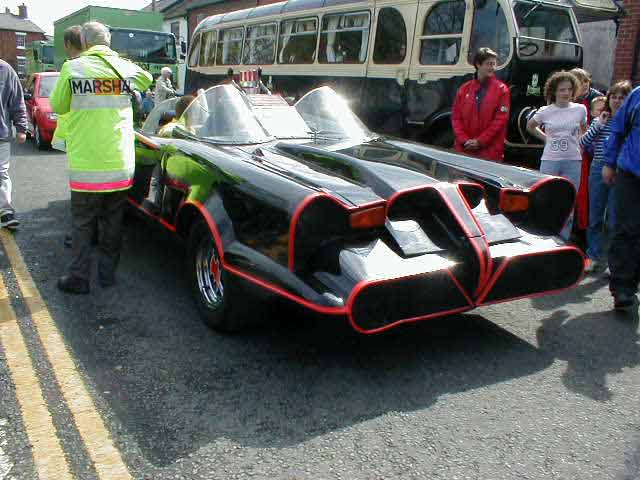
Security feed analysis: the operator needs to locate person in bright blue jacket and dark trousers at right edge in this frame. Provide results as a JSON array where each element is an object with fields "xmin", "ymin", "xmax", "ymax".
[{"xmin": 602, "ymin": 87, "xmax": 640, "ymax": 310}]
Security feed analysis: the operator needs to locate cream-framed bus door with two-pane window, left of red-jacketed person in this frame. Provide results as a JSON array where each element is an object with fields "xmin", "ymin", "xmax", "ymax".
[{"xmin": 406, "ymin": 0, "xmax": 475, "ymax": 145}]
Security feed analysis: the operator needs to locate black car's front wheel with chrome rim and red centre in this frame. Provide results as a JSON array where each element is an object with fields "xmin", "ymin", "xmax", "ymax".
[{"xmin": 188, "ymin": 222, "xmax": 250, "ymax": 333}]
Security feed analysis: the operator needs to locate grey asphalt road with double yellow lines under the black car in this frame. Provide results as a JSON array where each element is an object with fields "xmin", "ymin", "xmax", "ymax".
[{"xmin": 0, "ymin": 143, "xmax": 640, "ymax": 480}]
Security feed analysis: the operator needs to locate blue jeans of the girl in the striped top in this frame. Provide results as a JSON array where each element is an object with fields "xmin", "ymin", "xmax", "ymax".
[{"xmin": 587, "ymin": 161, "xmax": 615, "ymax": 261}]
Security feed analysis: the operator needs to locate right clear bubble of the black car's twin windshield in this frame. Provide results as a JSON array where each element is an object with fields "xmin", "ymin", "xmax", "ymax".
[{"xmin": 295, "ymin": 87, "xmax": 373, "ymax": 139}]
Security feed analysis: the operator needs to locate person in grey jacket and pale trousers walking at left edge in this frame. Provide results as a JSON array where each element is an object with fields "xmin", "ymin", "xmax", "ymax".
[{"xmin": 0, "ymin": 60, "xmax": 27, "ymax": 229}]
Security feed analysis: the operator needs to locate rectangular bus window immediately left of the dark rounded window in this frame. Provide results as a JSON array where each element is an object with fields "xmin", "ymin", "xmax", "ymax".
[{"xmin": 318, "ymin": 12, "xmax": 369, "ymax": 63}]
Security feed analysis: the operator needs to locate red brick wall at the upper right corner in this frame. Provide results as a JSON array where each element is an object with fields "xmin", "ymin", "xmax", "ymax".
[{"xmin": 613, "ymin": 0, "xmax": 640, "ymax": 85}]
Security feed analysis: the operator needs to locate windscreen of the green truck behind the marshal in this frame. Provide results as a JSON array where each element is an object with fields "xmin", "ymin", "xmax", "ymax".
[{"xmin": 111, "ymin": 29, "xmax": 176, "ymax": 64}]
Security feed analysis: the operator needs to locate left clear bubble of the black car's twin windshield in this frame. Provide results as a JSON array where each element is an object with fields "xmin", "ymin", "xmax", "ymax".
[{"xmin": 178, "ymin": 85, "xmax": 272, "ymax": 145}]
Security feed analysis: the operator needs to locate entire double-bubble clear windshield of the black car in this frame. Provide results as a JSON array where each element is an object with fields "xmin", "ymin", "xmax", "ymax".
[{"xmin": 176, "ymin": 85, "xmax": 373, "ymax": 145}]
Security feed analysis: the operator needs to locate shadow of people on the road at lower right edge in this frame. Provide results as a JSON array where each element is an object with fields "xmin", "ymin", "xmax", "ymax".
[{"xmin": 536, "ymin": 310, "xmax": 640, "ymax": 401}]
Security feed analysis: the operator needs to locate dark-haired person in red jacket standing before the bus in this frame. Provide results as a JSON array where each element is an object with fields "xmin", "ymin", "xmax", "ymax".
[{"xmin": 451, "ymin": 47, "xmax": 511, "ymax": 162}]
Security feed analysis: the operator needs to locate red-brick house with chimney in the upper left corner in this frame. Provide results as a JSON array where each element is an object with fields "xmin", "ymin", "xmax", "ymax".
[{"xmin": 0, "ymin": 4, "xmax": 46, "ymax": 78}]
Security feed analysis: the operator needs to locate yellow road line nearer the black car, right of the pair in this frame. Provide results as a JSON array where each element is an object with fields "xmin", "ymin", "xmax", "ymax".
[{"xmin": 0, "ymin": 230, "xmax": 131, "ymax": 480}]
